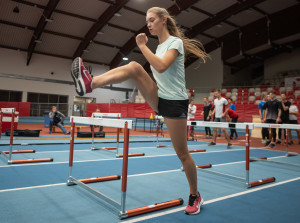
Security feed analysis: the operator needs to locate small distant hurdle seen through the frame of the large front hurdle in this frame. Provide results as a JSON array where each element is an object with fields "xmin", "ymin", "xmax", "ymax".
[{"xmin": 91, "ymin": 112, "xmax": 145, "ymax": 158}]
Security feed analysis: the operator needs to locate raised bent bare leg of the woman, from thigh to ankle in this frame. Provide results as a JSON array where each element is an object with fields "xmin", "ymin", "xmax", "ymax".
[{"xmin": 92, "ymin": 62, "xmax": 158, "ymax": 112}]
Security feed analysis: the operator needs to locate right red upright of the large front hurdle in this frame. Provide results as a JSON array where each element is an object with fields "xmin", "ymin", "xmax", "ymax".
[{"xmin": 119, "ymin": 122, "xmax": 129, "ymax": 218}]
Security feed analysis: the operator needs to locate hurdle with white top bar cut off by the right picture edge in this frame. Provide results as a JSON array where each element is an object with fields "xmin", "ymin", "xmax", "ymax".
[{"xmin": 250, "ymin": 123, "xmax": 300, "ymax": 167}]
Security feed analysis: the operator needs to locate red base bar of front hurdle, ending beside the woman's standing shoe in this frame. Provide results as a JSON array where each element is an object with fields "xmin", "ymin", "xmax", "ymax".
[{"xmin": 119, "ymin": 198, "xmax": 183, "ymax": 219}]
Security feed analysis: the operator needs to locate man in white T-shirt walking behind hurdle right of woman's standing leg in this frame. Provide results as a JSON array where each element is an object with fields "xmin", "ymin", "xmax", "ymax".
[{"xmin": 208, "ymin": 90, "xmax": 232, "ymax": 148}]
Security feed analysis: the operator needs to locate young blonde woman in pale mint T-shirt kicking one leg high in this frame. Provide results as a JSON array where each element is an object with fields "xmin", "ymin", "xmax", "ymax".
[{"xmin": 71, "ymin": 7, "xmax": 208, "ymax": 214}]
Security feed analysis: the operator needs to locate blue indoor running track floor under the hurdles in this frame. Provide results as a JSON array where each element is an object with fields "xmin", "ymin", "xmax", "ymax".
[{"xmin": 0, "ymin": 139, "xmax": 300, "ymax": 223}]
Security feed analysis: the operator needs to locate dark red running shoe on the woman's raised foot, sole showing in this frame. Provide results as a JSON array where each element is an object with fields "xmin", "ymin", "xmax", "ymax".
[{"xmin": 71, "ymin": 57, "xmax": 93, "ymax": 96}]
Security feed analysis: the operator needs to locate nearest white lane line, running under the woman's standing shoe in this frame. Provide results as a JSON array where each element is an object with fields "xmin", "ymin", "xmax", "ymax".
[{"xmin": 122, "ymin": 177, "xmax": 300, "ymax": 223}]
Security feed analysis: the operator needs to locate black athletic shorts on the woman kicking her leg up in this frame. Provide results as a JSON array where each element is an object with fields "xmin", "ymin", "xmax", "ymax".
[{"xmin": 158, "ymin": 98, "xmax": 189, "ymax": 119}]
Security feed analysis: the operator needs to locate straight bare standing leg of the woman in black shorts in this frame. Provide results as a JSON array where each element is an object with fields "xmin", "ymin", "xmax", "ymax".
[{"xmin": 165, "ymin": 119, "xmax": 198, "ymax": 195}]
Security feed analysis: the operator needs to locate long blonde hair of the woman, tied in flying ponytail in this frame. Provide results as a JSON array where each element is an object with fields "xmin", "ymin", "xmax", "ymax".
[{"xmin": 147, "ymin": 7, "xmax": 210, "ymax": 63}]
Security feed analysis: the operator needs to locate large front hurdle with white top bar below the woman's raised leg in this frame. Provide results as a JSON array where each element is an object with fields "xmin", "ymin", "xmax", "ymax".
[{"xmin": 67, "ymin": 116, "xmax": 183, "ymax": 219}]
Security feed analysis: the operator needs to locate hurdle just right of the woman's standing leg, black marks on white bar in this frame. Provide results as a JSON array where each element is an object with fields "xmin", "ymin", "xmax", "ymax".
[{"xmin": 188, "ymin": 121, "xmax": 276, "ymax": 188}]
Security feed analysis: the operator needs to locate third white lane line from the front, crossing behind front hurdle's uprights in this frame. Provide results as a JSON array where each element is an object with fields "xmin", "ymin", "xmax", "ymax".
[{"xmin": 0, "ymin": 149, "xmax": 244, "ymax": 168}]
